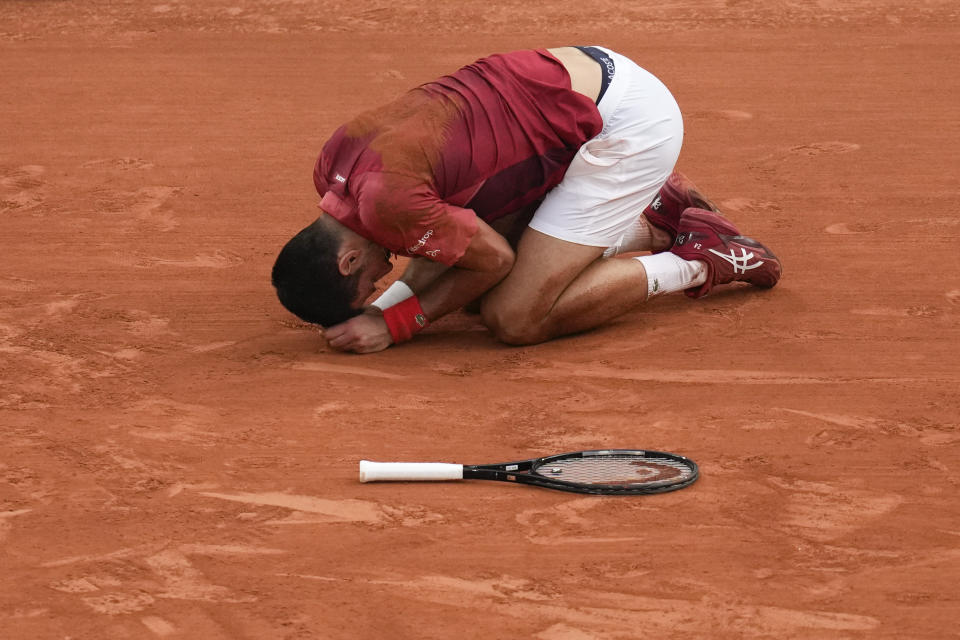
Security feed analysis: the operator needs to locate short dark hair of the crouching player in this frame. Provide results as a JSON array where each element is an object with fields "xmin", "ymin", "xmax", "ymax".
[{"xmin": 271, "ymin": 217, "xmax": 362, "ymax": 327}]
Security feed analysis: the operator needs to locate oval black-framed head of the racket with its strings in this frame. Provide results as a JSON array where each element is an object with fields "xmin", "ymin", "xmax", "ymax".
[{"xmin": 516, "ymin": 449, "xmax": 700, "ymax": 495}]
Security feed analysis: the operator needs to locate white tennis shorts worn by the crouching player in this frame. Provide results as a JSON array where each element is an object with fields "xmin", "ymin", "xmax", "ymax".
[{"xmin": 530, "ymin": 47, "xmax": 683, "ymax": 247}]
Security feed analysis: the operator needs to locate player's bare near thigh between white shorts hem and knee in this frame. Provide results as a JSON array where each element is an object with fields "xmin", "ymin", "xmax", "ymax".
[{"xmin": 482, "ymin": 228, "xmax": 604, "ymax": 329}]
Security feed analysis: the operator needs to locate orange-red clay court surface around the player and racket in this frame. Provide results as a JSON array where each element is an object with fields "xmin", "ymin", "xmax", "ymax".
[{"xmin": 0, "ymin": 0, "xmax": 960, "ymax": 640}]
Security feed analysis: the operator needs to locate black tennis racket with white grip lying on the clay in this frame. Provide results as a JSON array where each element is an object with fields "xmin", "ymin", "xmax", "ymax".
[{"xmin": 360, "ymin": 449, "xmax": 700, "ymax": 495}]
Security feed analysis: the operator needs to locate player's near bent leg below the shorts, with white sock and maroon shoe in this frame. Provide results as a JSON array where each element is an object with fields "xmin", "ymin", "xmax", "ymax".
[{"xmin": 482, "ymin": 202, "xmax": 782, "ymax": 344}]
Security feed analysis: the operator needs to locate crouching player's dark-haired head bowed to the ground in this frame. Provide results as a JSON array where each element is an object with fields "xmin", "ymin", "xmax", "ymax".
[{"xmin": 272, "ymin": 215, "xmax": 393, "ymax": 327}]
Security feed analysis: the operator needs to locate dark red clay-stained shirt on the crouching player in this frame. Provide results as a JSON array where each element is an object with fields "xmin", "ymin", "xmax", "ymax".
[{"xmin": 313, "ymin": 50, "xmax": 603, "ymax": 265}]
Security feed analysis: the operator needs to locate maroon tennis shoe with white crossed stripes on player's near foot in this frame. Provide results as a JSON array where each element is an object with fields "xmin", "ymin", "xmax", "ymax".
[{"xmin": 670, "ymin": 208, "xmax": 782, "ymax": 298}]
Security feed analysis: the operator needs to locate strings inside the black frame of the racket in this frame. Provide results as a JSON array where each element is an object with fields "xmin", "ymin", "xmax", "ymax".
[{"xmin": 535, "ymin": 455, "xmax": 693, "ymax": 486}]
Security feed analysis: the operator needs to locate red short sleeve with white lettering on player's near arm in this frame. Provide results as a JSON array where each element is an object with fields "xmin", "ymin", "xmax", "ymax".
[{"xmin": 354, "ymin": 172, "xmax": 479, "ymax": 266}]
